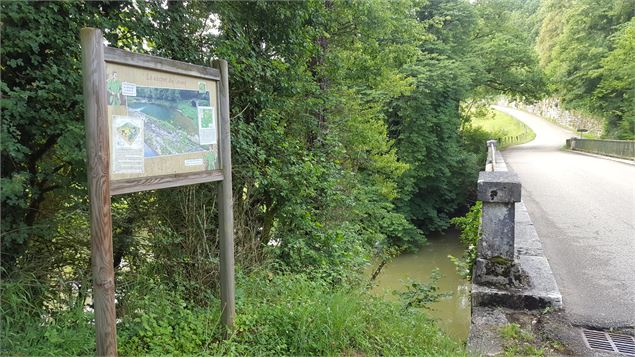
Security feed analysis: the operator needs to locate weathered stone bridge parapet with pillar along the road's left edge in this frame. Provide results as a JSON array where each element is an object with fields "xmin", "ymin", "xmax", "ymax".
[{"xmin": 468, "ymin": 140, "xmax": 562, "ymax": 355}]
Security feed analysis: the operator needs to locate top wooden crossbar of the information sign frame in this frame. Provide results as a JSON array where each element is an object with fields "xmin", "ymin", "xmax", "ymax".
[{"xmin": 104, "ymin": 47, "xmax": 220, "ymax": 81}]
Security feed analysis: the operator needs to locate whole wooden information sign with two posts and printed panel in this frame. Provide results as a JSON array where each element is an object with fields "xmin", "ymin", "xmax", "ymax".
[{"xmin": 81, "ymin": 28, "xmax": 235, "ymax": 356}]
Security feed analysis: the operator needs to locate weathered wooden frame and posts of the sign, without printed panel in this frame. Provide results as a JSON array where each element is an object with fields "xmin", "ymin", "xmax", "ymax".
[{"xmin": 80, "ymin": 28, "xmax": 235, "ymax": 356}]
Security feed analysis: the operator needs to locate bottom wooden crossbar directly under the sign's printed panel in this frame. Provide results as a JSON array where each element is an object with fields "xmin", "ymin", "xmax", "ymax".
[{"xmin": 110, "ymin": 170, "xmax": 223, "ymax": 196}]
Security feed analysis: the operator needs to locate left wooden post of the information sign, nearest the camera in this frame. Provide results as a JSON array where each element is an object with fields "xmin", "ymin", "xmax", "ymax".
[{"xmin": 80, "ymin": 28, "xmax": 117, "ymax": 356}]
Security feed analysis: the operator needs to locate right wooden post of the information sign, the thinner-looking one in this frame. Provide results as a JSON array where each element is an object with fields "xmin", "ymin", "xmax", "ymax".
[{"xmin": 213, "ymin": 60, "xmax": 236, "ymax": 328}]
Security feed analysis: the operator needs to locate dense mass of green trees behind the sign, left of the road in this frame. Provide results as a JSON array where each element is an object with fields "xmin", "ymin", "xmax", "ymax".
[{"xmin": 2, "ymin": 1, "xmax": 548, "ymax": 281}]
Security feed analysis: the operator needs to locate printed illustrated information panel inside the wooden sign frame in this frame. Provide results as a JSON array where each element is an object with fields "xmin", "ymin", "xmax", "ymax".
[{"xmin": 106, "ymin": 65, "xmax": 218, "ymax": 179}]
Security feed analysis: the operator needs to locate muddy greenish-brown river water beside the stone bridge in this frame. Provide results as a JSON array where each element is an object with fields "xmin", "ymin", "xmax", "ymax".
[{"xmin": 372, "ymin": 231, "xmax": 470, "ymax": 341}]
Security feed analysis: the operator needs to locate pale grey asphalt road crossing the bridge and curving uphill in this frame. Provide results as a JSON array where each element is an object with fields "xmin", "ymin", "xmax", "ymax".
[{"xmin": 496, "ymin": 107, "xmax": 635, "ymax": 328}]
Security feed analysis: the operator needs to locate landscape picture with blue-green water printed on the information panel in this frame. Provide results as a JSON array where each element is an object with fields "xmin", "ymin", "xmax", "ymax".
[{"xmin": 126, "ymin": 86, "xmax": 216, "ymax": 157}]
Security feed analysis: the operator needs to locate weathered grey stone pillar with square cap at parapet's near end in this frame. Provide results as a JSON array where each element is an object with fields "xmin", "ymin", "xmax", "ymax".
[{"xmin": 474, "ymin": 171, "xmax": 521, "ymax": 287}]
